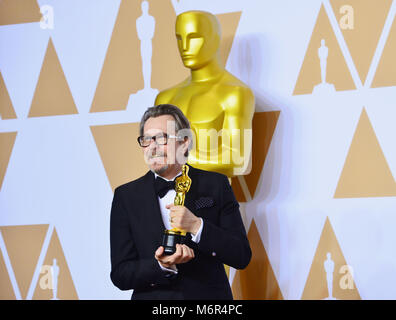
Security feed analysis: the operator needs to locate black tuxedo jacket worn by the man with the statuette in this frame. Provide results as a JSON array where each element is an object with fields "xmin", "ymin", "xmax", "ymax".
[{"xmin": 110, "ymin": 166, "xmax": 251, "ymax": 299}]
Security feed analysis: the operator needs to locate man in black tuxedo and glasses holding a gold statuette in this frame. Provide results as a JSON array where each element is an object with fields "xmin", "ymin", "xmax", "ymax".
[{"xmin": 110, "ymin": 104, "xmax": 251, "ymax": 299}]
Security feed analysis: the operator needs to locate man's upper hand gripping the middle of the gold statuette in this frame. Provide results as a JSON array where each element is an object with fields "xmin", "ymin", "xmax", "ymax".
[{"xmin": 166, "ymin": 203, "xmax": 201, "ymax": 235}]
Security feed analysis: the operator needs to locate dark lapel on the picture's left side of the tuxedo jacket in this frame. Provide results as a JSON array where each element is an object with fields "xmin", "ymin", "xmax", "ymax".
[{"xmin": 141, "ymin": 171, "xmax": 165, "ymax": 252}]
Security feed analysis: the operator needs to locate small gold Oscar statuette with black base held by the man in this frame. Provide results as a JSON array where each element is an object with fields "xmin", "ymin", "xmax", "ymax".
[{"xmin": 161, "ymin": 164, "xmax": 192, "ymax": 255}]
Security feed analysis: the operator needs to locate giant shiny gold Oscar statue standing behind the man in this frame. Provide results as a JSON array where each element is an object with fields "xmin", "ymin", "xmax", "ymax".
[{"xmin": 155, "ymin": 11, "xmax": 255, "ymax": 177}]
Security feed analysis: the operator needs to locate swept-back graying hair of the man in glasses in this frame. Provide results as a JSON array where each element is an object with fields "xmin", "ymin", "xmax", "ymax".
[{"xmin": 139, "ymin": 104, "xmax": 193, "ymax": 156}]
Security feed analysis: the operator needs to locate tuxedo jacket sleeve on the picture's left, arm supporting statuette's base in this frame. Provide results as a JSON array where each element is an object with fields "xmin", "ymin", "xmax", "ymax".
[{"xmin": 110, "ymin": 188, "xmax": 175, "ymax": 290}]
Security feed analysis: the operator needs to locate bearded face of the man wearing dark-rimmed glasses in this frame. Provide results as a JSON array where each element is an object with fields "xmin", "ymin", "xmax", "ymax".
[{"xmin": 143, "ymin": 115, "xmax": 188, "ymax": 175}]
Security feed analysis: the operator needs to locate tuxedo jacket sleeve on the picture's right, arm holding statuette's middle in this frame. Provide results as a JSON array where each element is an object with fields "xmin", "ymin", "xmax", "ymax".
[{"xmin": 198, "ymin": 175, "xmax": 252, "ymax": 269}]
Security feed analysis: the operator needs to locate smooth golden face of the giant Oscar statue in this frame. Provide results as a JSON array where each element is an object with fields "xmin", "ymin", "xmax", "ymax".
[{"xmin": 176, "ymin": 12, "xmax": 218, "ymax": 70}]
